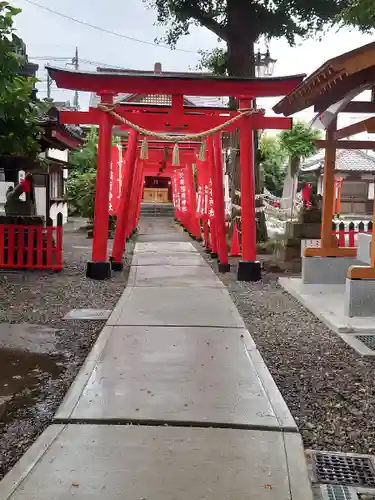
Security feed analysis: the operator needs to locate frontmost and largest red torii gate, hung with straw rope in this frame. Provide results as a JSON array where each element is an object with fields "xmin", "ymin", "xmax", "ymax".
[{"xmin": 47, "ymin": 67, "xmax": 304, "ymax": 281}]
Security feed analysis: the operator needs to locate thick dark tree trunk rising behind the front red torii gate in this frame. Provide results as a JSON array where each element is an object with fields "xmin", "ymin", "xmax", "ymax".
[{"xmin": 227, "ymin": 0, "xmax": 267, "ymax": 241}]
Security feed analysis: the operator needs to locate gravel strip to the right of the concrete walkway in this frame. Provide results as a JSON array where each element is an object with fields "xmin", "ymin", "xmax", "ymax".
[{"xmin": 197, "ymin": 245, "xmax": 375, "ymax": 454}]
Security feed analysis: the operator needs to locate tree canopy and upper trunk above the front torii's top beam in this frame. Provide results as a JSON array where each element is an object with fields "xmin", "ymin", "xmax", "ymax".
[{"xmin": 144, "ymin": 0, "xmax": 356, "ymax": 76}]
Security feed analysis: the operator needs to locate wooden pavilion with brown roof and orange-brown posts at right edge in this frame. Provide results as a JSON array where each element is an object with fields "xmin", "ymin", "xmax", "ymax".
[{"xmin": 274, "ymin": 42, "xmax": 375, "ymax": 292}]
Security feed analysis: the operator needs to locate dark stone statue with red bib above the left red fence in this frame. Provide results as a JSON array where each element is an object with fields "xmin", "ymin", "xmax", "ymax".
[{"xmin": 5, "ymin": 173, "xmax": 36, "ymax": 216}]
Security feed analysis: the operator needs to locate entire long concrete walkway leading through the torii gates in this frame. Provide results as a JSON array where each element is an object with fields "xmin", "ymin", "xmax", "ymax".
[{"xmin": 0, "ymin": 221, "xmax": 312, "ymax": 500}]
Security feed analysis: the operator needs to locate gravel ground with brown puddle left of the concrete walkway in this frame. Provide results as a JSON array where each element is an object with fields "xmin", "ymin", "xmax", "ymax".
[{"xmin": 0, "ymin": 223, "xmax": 134, "ymax": 478}]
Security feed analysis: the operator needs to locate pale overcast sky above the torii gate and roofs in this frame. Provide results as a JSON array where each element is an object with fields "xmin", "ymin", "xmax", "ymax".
[{"xmin": 10, "ymin": 0, "xmax": 374, "ymax": 126}]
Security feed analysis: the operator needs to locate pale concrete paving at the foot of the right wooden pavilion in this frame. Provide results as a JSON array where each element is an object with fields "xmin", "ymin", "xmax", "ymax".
[{"xmin": 279, "ymin": 278, "xmax": 375, "ymax": 334}]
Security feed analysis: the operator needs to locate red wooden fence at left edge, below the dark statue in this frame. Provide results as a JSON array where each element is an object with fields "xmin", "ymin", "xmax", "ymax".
[{"xmin": 0, "ymin": 213, "xmax": 63, "ymax": 271}]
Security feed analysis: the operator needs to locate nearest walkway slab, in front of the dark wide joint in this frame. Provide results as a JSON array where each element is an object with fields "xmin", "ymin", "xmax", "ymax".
[{"xmin": 0, "ymin": 425, "xmax": 312, "ymax": 500}]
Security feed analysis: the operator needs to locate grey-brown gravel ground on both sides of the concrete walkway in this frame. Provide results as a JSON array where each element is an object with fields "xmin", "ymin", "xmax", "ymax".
[{"xmin": 0, "ymin": 214, "xmax": 375, "ymax": 472}]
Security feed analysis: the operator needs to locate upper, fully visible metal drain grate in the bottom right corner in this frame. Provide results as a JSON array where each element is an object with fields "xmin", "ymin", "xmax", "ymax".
[{"xmin": 313, "ymin": 452, "xmax": 375, "ymax": 488}]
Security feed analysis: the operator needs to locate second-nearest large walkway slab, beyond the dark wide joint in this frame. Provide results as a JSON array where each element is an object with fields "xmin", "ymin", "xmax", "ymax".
[{"xmin": 55, "ymin": 327, "xmax": 297, "ymax": 432}]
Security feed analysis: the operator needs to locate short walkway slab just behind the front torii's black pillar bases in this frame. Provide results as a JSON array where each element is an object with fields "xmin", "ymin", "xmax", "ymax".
[{"xmin": 132, "ymin": 252, "xmax": 207, "ymax": 267}]
